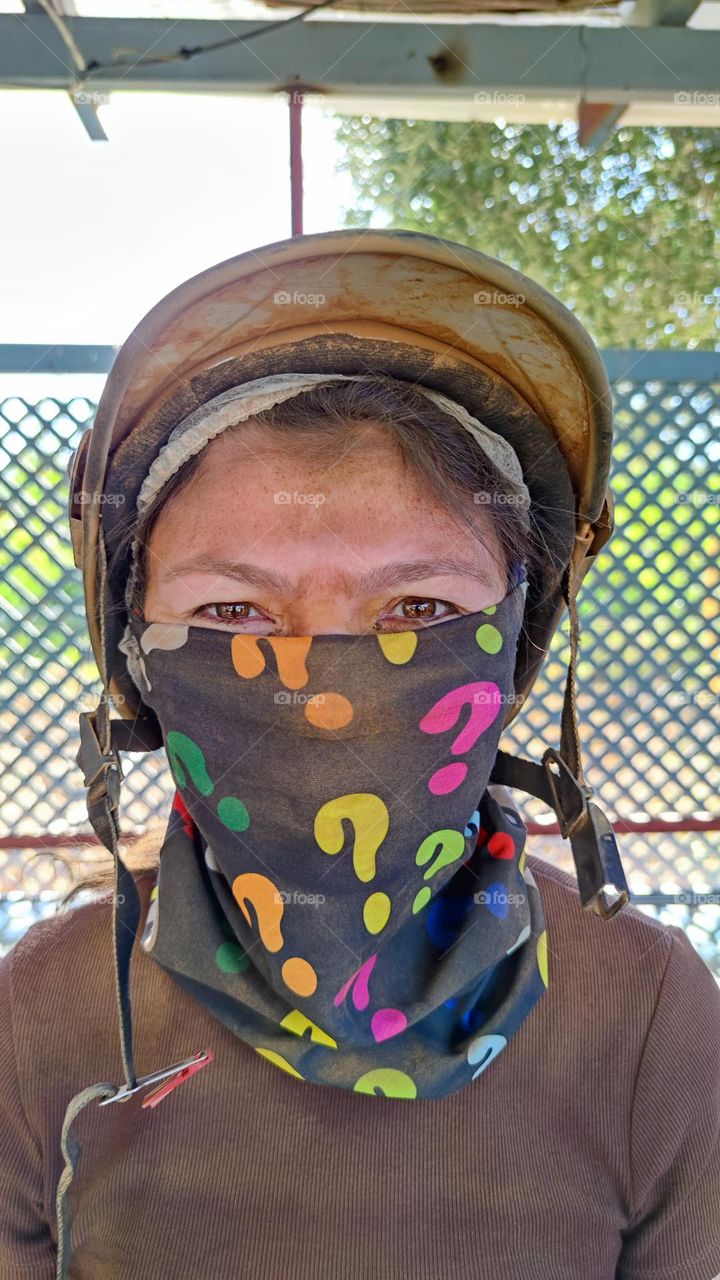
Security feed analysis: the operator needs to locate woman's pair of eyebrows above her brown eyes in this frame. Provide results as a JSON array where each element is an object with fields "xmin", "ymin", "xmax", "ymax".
[{"xmin": 161, "ymin": 556, "xmax": 497, "ymax": 595}]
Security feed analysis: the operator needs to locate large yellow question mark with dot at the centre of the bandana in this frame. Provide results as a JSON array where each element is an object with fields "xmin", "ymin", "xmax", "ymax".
[{"xmin": 315, "ymin": 791, "xmax": 392, "ymax": 933}]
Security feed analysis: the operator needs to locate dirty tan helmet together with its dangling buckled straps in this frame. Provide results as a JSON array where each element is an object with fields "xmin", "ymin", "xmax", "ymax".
[{"xmin": 58, "ymin": 229, "xmax": 629, "ymax": 1269}]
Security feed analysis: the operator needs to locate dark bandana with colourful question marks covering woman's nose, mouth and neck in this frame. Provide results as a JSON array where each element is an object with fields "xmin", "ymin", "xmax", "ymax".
[{"xmin": 124, "ymin": 581, "xmax": 547, "ymax": 1098}]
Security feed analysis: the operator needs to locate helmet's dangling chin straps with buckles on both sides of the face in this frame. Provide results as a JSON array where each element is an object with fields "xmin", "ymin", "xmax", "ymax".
[{"xmin": 56, "ymin": 530, "xmax": 630, "ymax": 1280}]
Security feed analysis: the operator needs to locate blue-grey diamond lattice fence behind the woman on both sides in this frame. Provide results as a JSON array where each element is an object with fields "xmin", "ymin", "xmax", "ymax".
[{"xmin": 0, "ymin": 352, "xmax": 720, "ymax": 980}]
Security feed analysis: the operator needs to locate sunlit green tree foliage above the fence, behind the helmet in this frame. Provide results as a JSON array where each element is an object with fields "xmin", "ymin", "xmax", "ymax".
[{"xmin": 337, "ymin": 115, "xmax": 720, "ymax": 349}]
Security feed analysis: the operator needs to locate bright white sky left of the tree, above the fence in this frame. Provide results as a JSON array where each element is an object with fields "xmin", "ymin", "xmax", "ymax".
[{"xmin": 0, "ymin": 90, "xmax": 352, "ymax": 353}]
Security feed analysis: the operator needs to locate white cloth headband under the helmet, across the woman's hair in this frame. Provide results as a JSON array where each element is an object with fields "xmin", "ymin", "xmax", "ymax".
[{"xmin": 137, "ymin": 374, "xmax": 530, "ymax": 518}]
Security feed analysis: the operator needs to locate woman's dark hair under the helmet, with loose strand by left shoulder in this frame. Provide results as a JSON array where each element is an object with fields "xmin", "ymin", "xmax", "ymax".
[{"xmin": 63, "ymin": 374, "xmax": 544, "ymax": 905}]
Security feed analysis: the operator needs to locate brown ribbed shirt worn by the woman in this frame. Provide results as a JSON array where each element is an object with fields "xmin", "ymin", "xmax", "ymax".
[{"xmin": 0, "ymin": 856, "xmax": 720, "ymax": 1280}]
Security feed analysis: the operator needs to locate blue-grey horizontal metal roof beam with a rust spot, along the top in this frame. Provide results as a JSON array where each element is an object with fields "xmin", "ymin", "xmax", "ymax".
[{"xmin": 0, "ymin": 14, "xmax": 720, "ymax": 102}]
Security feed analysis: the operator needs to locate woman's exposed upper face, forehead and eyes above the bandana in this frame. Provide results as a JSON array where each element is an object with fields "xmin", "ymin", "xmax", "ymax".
[{"xmin": 145, "ymin": 422, "xmax": 506, "ymax": 635}]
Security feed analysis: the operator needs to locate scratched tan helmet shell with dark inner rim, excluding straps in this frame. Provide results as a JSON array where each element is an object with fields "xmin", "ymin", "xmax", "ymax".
[{"xmin": 69, "ymin": 229, "xmax": 612, "ymax": 723}]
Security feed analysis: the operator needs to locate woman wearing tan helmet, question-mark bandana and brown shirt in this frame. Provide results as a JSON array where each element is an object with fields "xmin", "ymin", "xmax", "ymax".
[{"xmin": 0, "ymin": 232, "xmax": 720, "ymax": 1280}]
